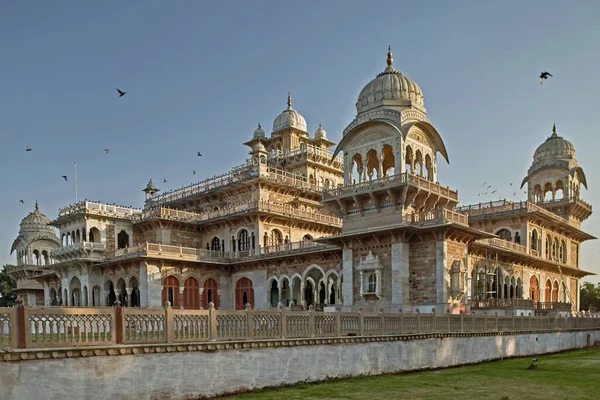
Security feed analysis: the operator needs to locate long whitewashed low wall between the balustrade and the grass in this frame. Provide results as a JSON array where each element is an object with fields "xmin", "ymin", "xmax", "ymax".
[{"xmin": 0, "ymin": 329, "xmax": 600, "ymax": 400}]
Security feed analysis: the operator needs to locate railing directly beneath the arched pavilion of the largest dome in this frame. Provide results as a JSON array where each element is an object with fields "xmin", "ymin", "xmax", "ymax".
[{"xmin": 323, "ymin": 172, "xmax": 458, "ymax": 201}]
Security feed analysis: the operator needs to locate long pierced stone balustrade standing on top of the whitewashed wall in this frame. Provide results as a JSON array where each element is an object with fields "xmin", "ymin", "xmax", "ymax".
[{"xmin": 0, "ymin": 303, "xmax": 600, "ymax": 349}]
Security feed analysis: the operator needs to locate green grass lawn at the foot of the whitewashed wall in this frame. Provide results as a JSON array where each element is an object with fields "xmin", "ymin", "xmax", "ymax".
[{"xmin": 227, "ymin": 349, "xmax": 600, "ymax": 400}]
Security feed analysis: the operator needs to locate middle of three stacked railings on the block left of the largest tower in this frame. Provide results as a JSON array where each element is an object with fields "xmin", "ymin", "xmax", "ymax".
[{"xmin": 134, "ymin": 200, "xmax": 342, "ymax": 227}]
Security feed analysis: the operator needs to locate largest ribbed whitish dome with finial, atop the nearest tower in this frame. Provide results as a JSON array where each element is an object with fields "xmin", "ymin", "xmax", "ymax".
[{"xmin": 356, "ymin": 49, "xmax": 425, "ymax": 114}]
